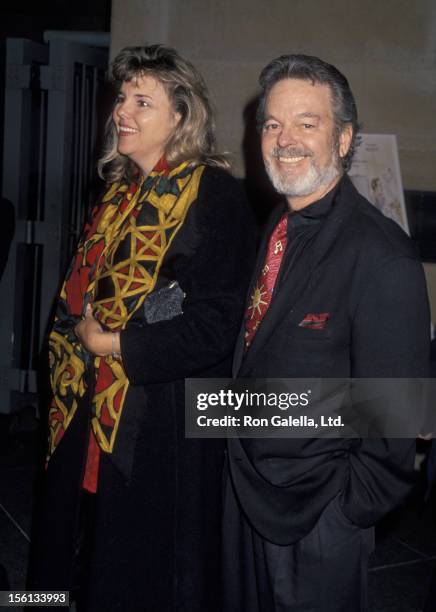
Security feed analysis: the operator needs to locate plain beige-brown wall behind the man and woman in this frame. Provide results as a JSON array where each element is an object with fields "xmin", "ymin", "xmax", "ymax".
[{"xmin": 112, "ymin": 0, "xmax": 436, "ymax": 321}]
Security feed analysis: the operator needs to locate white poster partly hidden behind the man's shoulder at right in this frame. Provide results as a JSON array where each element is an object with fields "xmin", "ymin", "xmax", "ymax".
[{"xmin": 348, "ymin": 134, "xmax": 410, "ymax": 234}]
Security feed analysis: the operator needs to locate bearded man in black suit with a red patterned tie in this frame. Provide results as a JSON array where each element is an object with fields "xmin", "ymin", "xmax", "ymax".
[{"xmin": 224, "ymin": 55, "xmax": 430, "ymax": 612}]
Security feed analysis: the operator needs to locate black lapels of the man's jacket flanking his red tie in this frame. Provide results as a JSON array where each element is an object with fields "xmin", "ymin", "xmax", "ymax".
[{"xmin": 240, "ymin": 176, "xmax": 357, "ymax": 376}]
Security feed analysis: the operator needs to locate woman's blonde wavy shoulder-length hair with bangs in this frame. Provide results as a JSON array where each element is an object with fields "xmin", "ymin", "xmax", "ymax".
[{"xmin": 98, "ymin": 45, "xmax": 230, "ymax": 182}]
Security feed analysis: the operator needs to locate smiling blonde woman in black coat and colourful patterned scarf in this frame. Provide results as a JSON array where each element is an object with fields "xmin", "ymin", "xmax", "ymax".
[{"xmin": 32, "ymin": 45, "xmax": 252, "ymax": 612}]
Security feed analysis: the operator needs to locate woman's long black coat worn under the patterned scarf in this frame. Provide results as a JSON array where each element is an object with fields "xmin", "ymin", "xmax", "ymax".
[{"xmin": 32, "ymin": 167, "xmax": 254, "ymax": 612}]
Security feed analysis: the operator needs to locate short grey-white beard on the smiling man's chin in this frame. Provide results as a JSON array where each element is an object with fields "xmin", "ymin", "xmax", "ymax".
[{"xmin": 265, "ymin": 155, "xmax": 340, "ymax": 197}]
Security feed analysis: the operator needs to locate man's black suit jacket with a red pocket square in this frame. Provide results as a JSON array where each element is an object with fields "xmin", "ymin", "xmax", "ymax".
[{"xmin": 228, "ymin": 176, "xmax": 430, "ymax": 544}]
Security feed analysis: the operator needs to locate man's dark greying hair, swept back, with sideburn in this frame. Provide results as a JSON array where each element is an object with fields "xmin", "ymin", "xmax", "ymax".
[{"xmin": 257, "ymin": 55, "xmax": 360, "ymax": 172}]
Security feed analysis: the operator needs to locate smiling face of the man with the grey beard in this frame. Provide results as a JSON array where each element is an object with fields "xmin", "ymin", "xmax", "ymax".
[{"xmin": 262, "ymin": 79, "xmax": 352, "ymax": 210}]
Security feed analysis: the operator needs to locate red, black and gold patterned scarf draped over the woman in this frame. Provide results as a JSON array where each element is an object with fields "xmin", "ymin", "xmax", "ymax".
[{"xmin": 47, "ymin": 161, "xmax": 204, "ymax": 460}]
